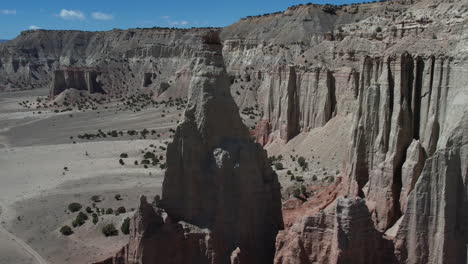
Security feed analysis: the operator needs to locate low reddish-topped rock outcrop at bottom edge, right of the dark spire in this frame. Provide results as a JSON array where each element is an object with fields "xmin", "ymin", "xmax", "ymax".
[{"xmin": 274, "ymin": 198, "xmax": 395, "ymax": 264}]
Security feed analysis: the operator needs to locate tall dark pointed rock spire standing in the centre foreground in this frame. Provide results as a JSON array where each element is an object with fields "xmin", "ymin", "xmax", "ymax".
[{"xmin": 97, "ymin": 32, "xmax": 283, "ymax": 263}]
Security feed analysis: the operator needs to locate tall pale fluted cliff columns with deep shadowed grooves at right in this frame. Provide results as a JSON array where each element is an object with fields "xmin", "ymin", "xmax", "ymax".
[{"xmin": 350, "ymin": 53, "xmax": 466, "ymax": 231}]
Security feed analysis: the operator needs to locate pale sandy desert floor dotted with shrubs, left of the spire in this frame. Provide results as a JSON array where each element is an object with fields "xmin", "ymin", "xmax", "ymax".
[{"xmin": 0, "ymin": 89, "xmax": 181, "ymax": 264}]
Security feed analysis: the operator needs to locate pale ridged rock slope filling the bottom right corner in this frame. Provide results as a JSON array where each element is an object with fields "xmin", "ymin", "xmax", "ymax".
[{"xmin": 395, "ymin": 111, "xmax": 468, "ymax": 263}]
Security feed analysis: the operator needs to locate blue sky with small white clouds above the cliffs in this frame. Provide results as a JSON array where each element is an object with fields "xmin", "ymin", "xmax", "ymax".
[{"xmin": 0, "ymin": 0, "xmax": 364, "ymax": 39}]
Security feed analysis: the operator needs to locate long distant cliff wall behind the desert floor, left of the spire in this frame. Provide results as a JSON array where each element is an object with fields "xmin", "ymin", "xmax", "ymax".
[{"xmin": 0, "ymin": 28, "xmax": 218, "ymax": 97}]
